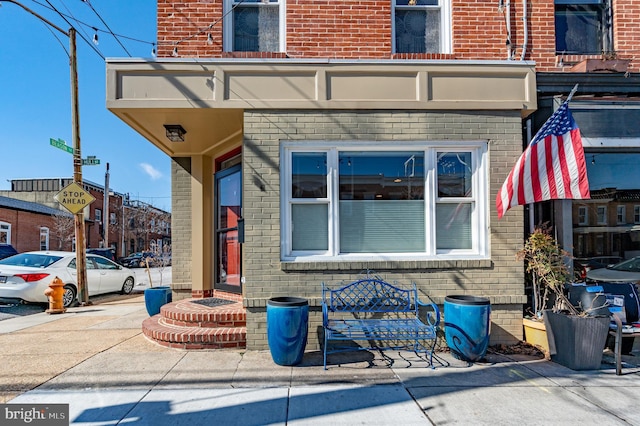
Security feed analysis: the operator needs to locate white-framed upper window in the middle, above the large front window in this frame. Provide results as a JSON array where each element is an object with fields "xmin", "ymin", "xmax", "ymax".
[{"xmin": 393, "ymin": 0, "xmax": 450, "ymax": 53}]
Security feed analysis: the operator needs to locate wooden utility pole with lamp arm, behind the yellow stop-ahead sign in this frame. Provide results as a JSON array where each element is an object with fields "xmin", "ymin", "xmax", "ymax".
[{"xmin": 0, "ymin": 0, "xmax": 89, "ymax": 305}]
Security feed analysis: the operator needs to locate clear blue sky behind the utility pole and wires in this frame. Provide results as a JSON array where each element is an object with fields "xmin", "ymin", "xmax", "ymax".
[{"xmin": 0, "ymin": 0, "xmax": 171, "ymax": 210}]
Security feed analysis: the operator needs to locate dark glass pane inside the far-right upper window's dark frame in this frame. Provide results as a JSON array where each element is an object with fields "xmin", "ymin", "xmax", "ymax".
[{"xmin": 555, "ymin": 5, "xmax": 602, "ymax": 54}]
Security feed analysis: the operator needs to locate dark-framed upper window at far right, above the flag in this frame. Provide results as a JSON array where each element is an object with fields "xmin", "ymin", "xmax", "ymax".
[{"xmin": 555, "ymin": 0, "xmax": 611, "ymax": 55}]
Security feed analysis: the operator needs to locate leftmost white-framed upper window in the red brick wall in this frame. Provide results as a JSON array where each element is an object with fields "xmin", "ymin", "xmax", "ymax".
[{"xmin": 224, "ymin": 0, "xmax": 285, "ymax": 52}]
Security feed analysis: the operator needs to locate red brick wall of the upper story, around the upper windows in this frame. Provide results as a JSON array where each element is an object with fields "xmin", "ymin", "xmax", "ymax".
[{"xmin": 157, "ymin": 0, "xmax": 640, "ymax": 72}]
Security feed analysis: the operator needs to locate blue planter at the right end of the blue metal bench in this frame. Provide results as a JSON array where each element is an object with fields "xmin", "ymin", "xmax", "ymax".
[{"xmin": 444, "ymin": 295, "xmax": 491, "ymax": 362}]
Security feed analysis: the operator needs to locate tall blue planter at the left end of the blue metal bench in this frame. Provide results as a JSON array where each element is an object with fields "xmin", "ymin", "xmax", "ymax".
[{"xmin": 267, "ymin": 297, "xmax": 309, "ymax": 365}]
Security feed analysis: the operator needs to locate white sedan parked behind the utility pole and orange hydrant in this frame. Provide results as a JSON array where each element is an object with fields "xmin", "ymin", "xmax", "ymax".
[{"xmin": 0, "ymin": 251, "xmax": 135, "ymax": 307}]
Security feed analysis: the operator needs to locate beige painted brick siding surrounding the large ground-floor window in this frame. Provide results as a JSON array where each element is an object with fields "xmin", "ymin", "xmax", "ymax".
[{"xmin": 243, "ymin": 111, "xmax": 525, "ymax": 349}]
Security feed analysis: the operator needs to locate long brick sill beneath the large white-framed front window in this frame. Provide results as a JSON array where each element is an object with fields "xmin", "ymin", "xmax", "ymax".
[{"xmin": 280, "ymin": 259, "xmax": 493, "ymax": 272}]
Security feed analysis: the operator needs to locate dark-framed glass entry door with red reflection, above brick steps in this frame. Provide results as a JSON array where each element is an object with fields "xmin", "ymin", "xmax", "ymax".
[{"xmin": 214, "ymin": 165, "xmax": 242, "ymax": 294}]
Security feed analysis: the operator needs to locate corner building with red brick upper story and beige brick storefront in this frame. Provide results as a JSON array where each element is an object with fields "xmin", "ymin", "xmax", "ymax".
[{"xmin": 107, "ymin": 0, "xmax": 640, "ymax": 349}]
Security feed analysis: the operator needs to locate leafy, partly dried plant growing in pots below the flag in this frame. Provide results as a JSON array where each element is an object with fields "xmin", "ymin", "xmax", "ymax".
[{"xmin": 516, "ymin": 223, "xmax": 580, "ymax": 318}]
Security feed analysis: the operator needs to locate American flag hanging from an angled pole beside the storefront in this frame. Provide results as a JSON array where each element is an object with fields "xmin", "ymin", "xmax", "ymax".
[{"xmin": 496, "ymin": 101, "xmax": 591, "ymax": 218}]
